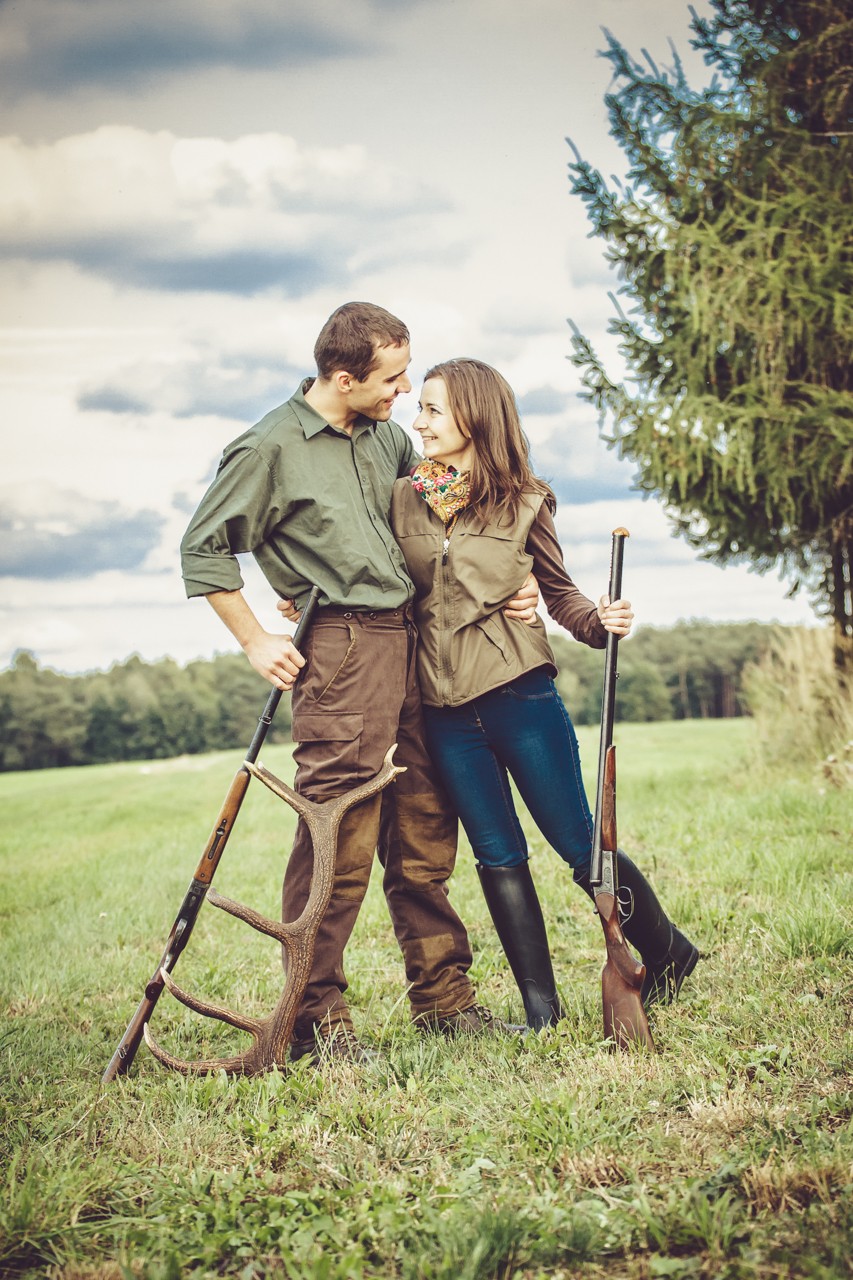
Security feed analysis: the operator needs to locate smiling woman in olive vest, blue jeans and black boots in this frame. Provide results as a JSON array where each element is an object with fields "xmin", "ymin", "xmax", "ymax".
[{"xmin": 391, "ymin": 360, "xmax": 699, "ymax": 1028}]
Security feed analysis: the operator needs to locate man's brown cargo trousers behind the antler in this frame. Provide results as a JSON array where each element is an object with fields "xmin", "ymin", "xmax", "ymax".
[{"xmin": 282, "ymin": 608, "xmax": 475, "ymax": 1039}]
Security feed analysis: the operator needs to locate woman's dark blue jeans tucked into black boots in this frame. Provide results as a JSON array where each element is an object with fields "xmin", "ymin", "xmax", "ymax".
[{"xmin": 424, "ymin": 668, "xmax": 593, "ymax": 872}]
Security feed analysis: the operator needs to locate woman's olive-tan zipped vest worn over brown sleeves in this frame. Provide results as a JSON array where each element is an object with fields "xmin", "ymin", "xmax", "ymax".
[{"xmin": 391, "ymin": 479, "xmax": 557, "ymax": 707}]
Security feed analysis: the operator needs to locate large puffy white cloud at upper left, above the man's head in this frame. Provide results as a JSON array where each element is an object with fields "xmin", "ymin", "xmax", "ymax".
[{"xmin": 0, "ymin": 125, "xmax": 455, "ymax": 297}]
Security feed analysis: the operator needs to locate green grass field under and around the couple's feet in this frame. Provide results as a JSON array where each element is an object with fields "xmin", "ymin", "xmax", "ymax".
[{"xmin": 0, "ymin": 721, "xmax": 853, "ymax": 1280}]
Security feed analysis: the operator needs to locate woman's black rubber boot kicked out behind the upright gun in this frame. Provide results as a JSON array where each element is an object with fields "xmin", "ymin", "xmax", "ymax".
[{"xmin": 575, "ymin": 849, "xmax": 699, "ymax": 1007}]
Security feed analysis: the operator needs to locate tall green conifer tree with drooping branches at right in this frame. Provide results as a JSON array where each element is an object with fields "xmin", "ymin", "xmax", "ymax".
[{"xmin": 570, "ymin": 0, "xmax": 853, "ymax": 667}]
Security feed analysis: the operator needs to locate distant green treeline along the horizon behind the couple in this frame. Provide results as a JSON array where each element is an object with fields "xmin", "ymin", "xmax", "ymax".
[{"xmin": 0, "ymin": 622, "xmax": 780, "ymax": 771}]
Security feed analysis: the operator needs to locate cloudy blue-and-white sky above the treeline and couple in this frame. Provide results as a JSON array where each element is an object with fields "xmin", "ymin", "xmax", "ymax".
[{"xmin": 0, "ymin": 0, "xmax": 815, "ymax": 672}]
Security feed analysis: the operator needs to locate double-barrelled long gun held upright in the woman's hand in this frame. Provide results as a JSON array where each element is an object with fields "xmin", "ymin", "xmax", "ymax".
[{"xmin": 589, "ymin": 529, "xmax": 654, "ymax": 1050}]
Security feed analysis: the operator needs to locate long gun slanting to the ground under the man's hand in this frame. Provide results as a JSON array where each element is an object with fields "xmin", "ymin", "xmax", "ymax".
[{"xmin": 101, "ymin": 586, "xmax": 320, "ymax": 1084}]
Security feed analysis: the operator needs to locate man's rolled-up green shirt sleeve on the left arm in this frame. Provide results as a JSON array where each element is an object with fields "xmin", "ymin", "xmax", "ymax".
[{"xmin": 181, "ymin": 447, "xmax": 278, "ymax": 598}]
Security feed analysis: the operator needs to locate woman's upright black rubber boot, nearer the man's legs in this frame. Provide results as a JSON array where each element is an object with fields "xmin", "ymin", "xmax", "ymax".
[{"xmin": 476, "ymin": 863, "xmax": 562, "ymax": 1030}]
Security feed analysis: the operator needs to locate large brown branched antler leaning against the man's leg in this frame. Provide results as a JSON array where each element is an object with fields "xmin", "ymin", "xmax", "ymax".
[{"xmin": 145, "ymin": 742, "xmax": 406, "ymax": 1075}]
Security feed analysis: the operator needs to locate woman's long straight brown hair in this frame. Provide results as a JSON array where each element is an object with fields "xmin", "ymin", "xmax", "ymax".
[{"xmin": 424, "ymin": 357, "xmax": 557, "ymax": 522}]
